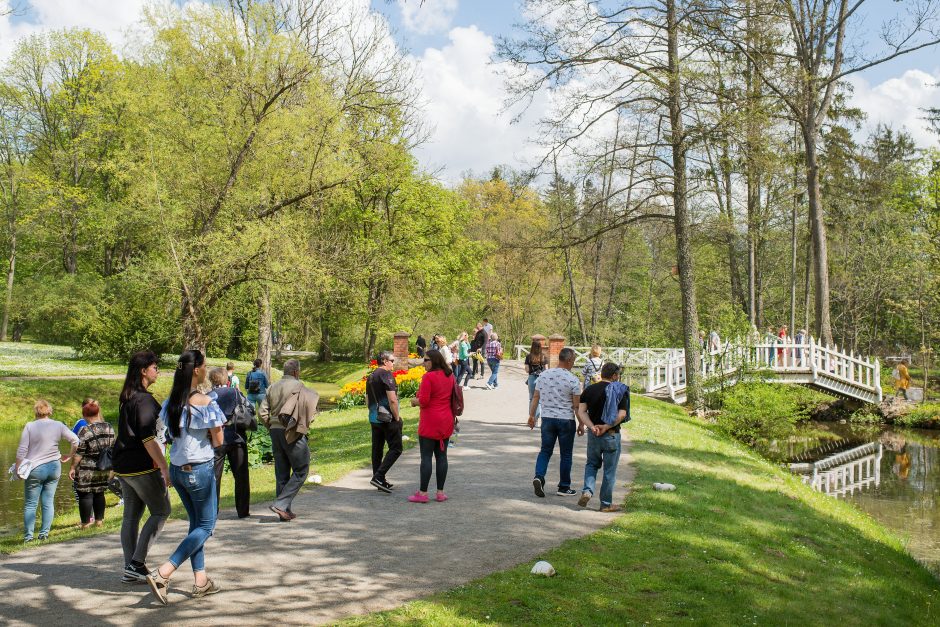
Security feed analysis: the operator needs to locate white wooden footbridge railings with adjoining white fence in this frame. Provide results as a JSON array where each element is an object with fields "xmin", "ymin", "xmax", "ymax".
[{"xmin": 516, "ymin": 338, "xmax": 882, "ymax": 403}]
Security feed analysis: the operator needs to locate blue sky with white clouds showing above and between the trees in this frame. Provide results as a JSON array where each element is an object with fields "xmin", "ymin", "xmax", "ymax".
[{"xmin": 0, "ymin": 0, "xmax": 940, "ymax": 182}]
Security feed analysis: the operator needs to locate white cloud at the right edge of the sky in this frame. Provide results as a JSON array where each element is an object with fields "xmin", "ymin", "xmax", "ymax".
[{"xmin": 849, "ymin": 69, "xmax": 940, "ymax": 148}]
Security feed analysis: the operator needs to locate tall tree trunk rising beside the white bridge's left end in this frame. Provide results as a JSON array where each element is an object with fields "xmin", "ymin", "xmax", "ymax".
[{"xmin": 666, "ymin": 0, "xmax": 703, "ymax": 410}]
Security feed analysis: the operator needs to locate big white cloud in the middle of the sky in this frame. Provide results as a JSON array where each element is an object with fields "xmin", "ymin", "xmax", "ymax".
[{"xmin": 408, "ymin": 26, "xmax": 547, "ymax": 182}]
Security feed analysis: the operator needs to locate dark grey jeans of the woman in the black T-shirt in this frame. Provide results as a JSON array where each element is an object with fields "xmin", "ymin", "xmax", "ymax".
[{"xmin": 118, "ymin": 470, "xmax": 170, "ymax": 566}]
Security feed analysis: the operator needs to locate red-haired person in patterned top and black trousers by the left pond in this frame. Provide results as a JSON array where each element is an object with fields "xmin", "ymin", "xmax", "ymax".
[{"xmin": 69, "ymin": 398, "xmax": 114, "ymax": 529}]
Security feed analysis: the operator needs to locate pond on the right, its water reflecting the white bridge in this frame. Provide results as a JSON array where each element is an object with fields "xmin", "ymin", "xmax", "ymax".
[{"xmin": 778, "ymin": 423, "xmax": 940, "ymax": 572}]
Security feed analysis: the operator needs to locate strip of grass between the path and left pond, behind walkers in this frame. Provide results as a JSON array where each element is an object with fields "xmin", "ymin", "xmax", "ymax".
[{"xmin": 0, "ymin": 407, "xmax": 418, "ymax": 554}]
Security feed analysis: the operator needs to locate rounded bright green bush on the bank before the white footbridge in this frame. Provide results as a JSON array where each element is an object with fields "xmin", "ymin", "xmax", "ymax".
[{"xmin": 718, "ymin": 383, "xmax": 808, "ymax": 445}]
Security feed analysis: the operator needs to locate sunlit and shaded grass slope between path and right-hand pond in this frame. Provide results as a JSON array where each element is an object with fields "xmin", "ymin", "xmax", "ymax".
[{"xmin": 350, "ymin": 398, "xmax": 940, "ymax": 625}]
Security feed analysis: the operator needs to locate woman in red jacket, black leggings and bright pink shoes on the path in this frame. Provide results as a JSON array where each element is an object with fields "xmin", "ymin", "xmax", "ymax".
[{"xmin": 408, "ymin": 350, "xmax": 456, "ymax": 503}]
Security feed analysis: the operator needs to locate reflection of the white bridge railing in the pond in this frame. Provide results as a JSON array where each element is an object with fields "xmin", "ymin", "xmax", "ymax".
[{"xmin": 790, "ymin": 442, "xmax": 882, "ymax": 496}]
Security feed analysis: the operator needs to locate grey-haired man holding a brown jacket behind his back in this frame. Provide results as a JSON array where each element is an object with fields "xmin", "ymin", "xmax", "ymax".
[{"xmin": 261, "ymin": 359, "xmax": 319, "ymax": 522}]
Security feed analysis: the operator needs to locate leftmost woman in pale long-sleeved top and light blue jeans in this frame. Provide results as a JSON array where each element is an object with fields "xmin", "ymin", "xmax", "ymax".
[{"xmin": 14, "ymin": 399, "xmax": 79, "ymax": 542}]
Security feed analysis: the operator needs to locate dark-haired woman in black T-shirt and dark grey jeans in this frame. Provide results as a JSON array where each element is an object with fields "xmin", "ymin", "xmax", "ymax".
[{"xmin": 111, "ymin": 351, "xmax": 170, "ymax": 584}]
